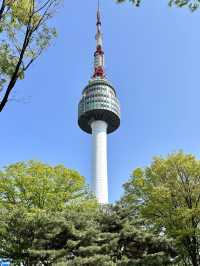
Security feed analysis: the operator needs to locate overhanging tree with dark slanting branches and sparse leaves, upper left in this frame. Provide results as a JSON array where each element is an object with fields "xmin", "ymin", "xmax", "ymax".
[{"xmin": 0, "ymin": 0, "xmax": 60, "ymax": 112}]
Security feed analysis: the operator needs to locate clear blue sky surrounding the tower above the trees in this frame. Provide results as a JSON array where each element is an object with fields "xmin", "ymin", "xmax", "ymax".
[{"xmin": 0, "ymin": 0, "xmax": 200, "ymax": 202}]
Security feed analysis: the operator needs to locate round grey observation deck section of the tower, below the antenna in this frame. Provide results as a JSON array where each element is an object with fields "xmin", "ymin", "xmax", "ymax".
[{"xmin": 78, "ymin": 78, "xmax": 120, "ymax": 134}]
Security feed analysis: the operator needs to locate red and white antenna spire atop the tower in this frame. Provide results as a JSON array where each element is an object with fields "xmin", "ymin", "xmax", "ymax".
[{"xmin": 93, "ymin": 0, "xmax": 105, "ymax": 78}]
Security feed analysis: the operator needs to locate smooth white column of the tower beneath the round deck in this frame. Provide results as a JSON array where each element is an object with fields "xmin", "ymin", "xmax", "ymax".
[{"xmin": 91, "ymin": 120, "xmax": 108, "ymax": 204}]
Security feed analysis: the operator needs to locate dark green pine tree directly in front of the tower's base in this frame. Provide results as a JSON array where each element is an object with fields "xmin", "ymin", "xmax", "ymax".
[{"xmin": 65, "ymin": 205, "xmax": 177, "ymax": 266}]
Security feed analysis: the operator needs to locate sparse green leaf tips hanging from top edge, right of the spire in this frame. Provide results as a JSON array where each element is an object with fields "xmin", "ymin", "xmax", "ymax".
[{"xmin": 117, "ymin": 0, "xmax": 200, "ymax": 11}]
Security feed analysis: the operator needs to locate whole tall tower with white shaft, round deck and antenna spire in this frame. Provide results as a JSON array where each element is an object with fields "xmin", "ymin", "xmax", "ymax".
[{"xmin": 78, "ymin": 1, "xmax": 120, "ymax": 204}]
